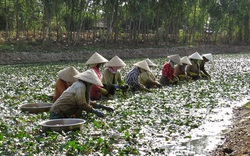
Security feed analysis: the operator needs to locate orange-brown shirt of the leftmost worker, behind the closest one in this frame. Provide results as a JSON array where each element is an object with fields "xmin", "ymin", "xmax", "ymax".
[{"xmin": 53, "ymin": 78, "xmax": 69, "ymax": 103}]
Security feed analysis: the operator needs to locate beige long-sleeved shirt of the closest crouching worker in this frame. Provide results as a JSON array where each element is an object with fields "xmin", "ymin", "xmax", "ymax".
[{"xmin": 50, "ymin": 80, "xmax": 92, "ymax": 117}]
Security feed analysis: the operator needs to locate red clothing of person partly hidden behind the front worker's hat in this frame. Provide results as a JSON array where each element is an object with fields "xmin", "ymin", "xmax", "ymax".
[{"xmin": 90, "ymin": 67, "xmax": 102, "ymax": 100}]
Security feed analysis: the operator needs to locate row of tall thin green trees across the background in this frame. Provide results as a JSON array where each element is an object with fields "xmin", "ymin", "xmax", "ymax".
[{"xmin": 0, "ymin": 0, "xmax": 250, "ymax": 45}]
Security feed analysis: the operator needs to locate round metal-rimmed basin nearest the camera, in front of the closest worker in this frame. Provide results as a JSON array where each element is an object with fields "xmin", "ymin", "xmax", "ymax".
[{"xmin": 40, "ymin": 118, "xmax": 85, "ymax": 132}]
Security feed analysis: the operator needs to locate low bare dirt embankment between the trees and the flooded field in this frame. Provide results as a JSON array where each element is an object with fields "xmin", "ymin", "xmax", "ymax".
[{"xmin": 0, "ymin": 45, "xmax": 250, "ymax": 65}]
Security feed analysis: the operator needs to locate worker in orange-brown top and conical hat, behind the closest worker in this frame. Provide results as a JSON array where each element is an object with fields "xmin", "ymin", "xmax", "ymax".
[{"xmin": 52, "ymin": 66, "xmax": 79, "ymax": 103}]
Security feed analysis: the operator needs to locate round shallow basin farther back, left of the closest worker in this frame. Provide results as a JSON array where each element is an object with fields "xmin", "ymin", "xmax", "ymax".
[{"xmin": 20, "ymin": 103, "xmax": 52, "ymax": 113}]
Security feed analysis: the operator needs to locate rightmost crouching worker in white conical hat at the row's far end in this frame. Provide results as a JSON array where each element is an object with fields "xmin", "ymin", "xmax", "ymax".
[{"xmin": 200, "ymin": 53, "xmax": 214, "ymax": 79}]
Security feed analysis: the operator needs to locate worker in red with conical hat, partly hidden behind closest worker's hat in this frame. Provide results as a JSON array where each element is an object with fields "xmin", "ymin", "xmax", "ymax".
[{"xmin": 86, "ymin": 52, "xmax": 108, "ymax": 100}]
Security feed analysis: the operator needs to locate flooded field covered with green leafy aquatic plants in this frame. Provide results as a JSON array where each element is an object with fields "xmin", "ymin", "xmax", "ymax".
[{"xmin": 0, "ymin": 54, "xmax": 250, "ymax": 155}]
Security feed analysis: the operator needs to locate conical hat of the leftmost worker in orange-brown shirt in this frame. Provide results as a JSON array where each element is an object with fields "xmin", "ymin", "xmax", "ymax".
[{"xmin": 58, "ymin": 67, "xmax": 79, "ymax": 83}]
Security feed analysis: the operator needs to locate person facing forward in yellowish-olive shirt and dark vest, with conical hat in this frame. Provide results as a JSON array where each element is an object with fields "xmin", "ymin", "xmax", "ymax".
[{"xmin": 102, "ymin": 56, "xmax": 128, "ymax": 95}]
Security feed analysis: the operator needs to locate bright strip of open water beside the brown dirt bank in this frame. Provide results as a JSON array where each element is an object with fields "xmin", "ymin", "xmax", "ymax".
[{"xmin": 185, "ymin": 98, "xmax": 248, "ymax": 155}]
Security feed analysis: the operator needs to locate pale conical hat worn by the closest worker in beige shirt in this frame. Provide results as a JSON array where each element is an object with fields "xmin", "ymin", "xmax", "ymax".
[{"xmin": 74, "ymin": 69, "xmax": 103, "ymax": 86}]
